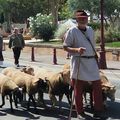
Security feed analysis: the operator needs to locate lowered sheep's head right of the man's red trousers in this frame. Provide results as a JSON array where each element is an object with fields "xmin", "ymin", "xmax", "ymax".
[{"xmin": 102, "ymin": 86, "xmax": 116, "ymax": 101}]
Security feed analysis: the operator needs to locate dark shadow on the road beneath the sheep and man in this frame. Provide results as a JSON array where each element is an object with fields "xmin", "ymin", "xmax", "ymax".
[{"xmin": 0, "ymin": 100, "xmax": 120, "ymax": 120}]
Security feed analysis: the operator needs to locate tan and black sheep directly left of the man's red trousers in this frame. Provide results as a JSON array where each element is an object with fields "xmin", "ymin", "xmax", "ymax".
[{"xmin": 46, "ymin": 70, "xmax": 71, "ymax": 109}]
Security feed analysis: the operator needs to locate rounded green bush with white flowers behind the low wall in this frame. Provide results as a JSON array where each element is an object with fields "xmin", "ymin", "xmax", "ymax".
[{"xmin": 28, "ymin": 13, "xmax": 54, "ymax": 41}]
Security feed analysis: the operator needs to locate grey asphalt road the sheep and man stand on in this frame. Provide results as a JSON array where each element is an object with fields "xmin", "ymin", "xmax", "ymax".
[{"xmin": 0, "ymin": 59, "xmax": 120, "ymax": 120}]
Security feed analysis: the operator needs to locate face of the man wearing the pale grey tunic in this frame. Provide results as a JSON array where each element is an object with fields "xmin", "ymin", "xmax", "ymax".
[{"xmin": 75, "ymin": 12, "xmax": 88, "ymax": 25}]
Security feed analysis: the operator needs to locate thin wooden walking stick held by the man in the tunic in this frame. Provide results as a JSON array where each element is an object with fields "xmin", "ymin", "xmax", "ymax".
[{"xmin": 68, "ymin": 56, "xmax": 81, "ymax": 120}]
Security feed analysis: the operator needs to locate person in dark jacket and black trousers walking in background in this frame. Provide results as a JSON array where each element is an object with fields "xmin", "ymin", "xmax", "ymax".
[{"xmin": 9, "ymin": 28, "xmax": 25, "ymax": 67}]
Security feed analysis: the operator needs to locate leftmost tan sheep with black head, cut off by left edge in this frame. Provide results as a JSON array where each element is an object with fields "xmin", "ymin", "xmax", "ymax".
[{"xmin": 0, "ymin": 73, "xmax": 22, "ymax": 112}]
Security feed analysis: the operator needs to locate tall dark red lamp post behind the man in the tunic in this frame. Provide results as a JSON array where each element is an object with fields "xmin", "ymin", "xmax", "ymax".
[{"xmin": 99, "ymin": 0, "xmax": 107, "ymax": 69}]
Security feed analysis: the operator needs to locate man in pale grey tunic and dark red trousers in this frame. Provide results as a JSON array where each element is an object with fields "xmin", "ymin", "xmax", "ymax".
[{"xmin": 63, "ymin": 10, "xmax": 104, "ymax": 120}]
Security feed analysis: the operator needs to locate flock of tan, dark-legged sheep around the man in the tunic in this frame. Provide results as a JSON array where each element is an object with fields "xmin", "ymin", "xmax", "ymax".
[{"xmin": 0, "ymin": 64, "xmax": 116, "ymax": 112}]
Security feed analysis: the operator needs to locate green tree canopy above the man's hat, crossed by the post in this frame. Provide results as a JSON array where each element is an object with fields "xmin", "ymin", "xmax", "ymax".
[{"xmin": 67, "ymin": 0, "xmax": 120, "ymax": 24}]
